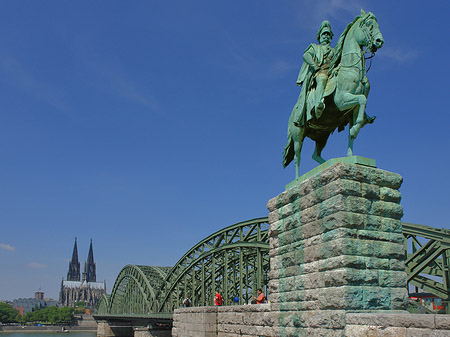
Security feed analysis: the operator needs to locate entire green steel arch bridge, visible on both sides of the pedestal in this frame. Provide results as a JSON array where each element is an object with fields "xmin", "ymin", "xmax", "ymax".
[{"xmin": 95, "ymin": 218, "xmax": 450, "ymax": 321}]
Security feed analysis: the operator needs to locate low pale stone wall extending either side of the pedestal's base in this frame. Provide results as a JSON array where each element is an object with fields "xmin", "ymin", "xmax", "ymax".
[{"xmin": 172, "ymin": 304, "xmax": 450, "ymax": 337}]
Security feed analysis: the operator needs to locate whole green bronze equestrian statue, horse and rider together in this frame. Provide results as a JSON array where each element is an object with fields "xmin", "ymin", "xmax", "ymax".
[{"xmin": 283, "ymin": 10, "xmax": 384, "ymax": 178}]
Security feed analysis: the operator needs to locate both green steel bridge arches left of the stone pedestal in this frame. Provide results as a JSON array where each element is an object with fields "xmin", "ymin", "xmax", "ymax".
[{"xmin": 97, "ymin": 218, "xmax": 269, "ymax": 316}]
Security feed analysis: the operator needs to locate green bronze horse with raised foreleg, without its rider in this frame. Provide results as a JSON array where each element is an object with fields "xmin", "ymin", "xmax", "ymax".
[{"xmin": 283, "ymin": 11, "xmax": 384, "ymax": 178}]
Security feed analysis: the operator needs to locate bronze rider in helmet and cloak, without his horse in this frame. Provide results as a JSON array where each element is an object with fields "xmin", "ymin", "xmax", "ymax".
[{"xmin": 296, "ymin": 20, "xmax": 334, "ymax": 126}]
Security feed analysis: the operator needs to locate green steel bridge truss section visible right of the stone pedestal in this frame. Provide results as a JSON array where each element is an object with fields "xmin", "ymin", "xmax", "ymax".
[{"xmin": 403, "ymin": 222, "xmax": 450, "ymax": 300}]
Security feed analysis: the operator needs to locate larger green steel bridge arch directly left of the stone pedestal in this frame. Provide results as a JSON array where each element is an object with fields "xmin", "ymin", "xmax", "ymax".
[{"xmin": 152, "ymin": 218, "xmax": 269, "ymax": 312}]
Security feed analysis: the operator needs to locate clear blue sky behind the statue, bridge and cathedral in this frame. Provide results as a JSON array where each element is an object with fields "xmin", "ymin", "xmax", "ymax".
[{"xmin": 0, "ymin": 0, "xmax": 450, "ymax": 299}]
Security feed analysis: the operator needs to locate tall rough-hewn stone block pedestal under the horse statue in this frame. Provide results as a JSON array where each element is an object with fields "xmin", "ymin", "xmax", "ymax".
[{"xmin": 267, "ymin": 157, "xmax": 408, "ymax": 336}]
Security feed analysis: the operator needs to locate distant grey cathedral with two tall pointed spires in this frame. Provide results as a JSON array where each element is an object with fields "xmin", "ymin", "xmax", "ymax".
[{"xmin": 59, "ymin": 238, "xmax": 106, "ymax": 307}]
